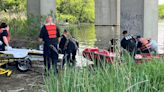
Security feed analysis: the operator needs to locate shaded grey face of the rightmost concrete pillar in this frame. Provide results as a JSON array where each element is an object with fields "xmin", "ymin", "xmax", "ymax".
[{"xmin": 121, "ymin": 0, "xmax": 144, "ymax": 36}]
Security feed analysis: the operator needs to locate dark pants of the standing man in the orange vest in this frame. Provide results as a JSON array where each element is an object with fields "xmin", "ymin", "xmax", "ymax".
[{"xmin": 43, "ymin": 44, "xmax": 59, "ymax": 73}]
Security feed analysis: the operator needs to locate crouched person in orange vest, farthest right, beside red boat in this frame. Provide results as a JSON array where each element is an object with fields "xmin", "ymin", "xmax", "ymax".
[{"xmin": 137, "ymin": 36, "xmax": 151, "ymax": 53}]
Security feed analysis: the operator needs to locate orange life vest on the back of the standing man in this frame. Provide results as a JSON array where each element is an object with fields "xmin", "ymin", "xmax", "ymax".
[{"xmin": 45, "ymin": 24, "xmax": 57, "ymax": 39}]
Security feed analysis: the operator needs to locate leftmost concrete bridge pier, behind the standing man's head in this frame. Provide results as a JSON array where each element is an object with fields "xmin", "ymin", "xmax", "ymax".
[{"xmin": 27, "ymin": 0, "xmax": 56, "ymax": 25}]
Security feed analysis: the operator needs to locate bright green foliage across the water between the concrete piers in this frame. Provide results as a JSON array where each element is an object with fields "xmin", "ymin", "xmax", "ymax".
[{"xmin": 56, "ymin": 0, "xmax": 95, "ymax": 22}]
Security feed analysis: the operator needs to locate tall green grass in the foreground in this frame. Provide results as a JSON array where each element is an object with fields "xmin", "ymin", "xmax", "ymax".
[{"xmin": 45, "ymin": 56, "xmax": 164, "ymax": 92}]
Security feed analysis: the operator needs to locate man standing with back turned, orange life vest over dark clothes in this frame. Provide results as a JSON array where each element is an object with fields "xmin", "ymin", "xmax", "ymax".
[{"xmin": 39, "ymin": 16, "xmax": 60, "ymax": 73}]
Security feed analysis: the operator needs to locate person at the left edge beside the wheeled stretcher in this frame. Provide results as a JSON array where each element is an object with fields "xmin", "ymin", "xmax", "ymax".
[{"xmin": 0, "ymin": 23, "xmax": 12, "ymax": 51}]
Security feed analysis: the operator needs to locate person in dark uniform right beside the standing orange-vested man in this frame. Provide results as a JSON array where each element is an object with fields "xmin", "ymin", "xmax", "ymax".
[{"xmin": 59, "ymin": 29, "xmax": 78, "ymax": 67}]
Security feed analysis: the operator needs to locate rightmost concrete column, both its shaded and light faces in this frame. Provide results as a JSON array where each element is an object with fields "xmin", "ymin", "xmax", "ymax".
[{"xmin": 121, "ymin": 0, "xmax": 158, "ymax": 40}]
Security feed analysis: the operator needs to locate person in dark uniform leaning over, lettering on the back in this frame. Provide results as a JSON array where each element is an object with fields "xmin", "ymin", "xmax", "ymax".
[{"xmin": 121, "ymin": 30, "xmax": 137, "ymax": 56}]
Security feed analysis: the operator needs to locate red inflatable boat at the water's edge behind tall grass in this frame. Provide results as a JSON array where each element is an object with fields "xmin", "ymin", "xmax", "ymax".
[{"xmin": 83, "ymin": 48, "xmax": 164, "ymax": 64}]
